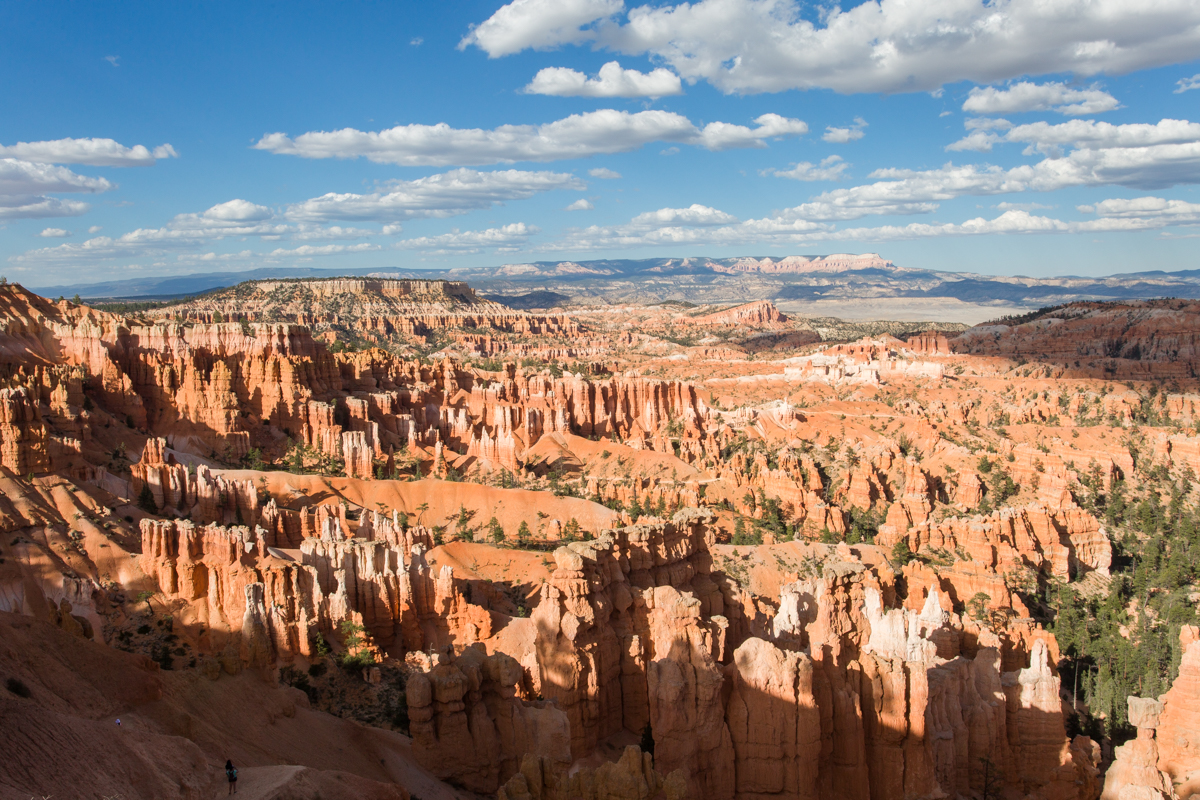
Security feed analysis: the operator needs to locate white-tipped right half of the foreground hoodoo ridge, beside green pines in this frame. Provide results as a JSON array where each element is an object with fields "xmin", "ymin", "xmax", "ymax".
[{"xmin": 758, "ymin": 563, "xmax": 1098, "ymax": 799}]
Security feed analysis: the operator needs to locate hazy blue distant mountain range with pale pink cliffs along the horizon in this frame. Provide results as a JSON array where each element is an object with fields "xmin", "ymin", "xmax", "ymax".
[{"xmin": 30, "ymin": 253, "xmax": 1200, "ymax": 308}]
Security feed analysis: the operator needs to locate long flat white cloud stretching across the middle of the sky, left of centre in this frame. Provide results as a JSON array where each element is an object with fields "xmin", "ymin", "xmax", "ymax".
[{"xmin": 254, "ymin": 109, "xmax": 808, "ymax": 167}]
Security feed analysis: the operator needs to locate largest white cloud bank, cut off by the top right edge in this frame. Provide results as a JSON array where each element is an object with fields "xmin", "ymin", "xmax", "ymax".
[{"xmin": 460, "ymin": 0, "xmax": 1200, "ymax": 94}]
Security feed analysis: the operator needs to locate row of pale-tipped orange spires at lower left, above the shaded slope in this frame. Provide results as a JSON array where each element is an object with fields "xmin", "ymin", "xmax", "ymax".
[{"xmin": 140, "ymin": 517, "xmax": 491, "ymax": 663}]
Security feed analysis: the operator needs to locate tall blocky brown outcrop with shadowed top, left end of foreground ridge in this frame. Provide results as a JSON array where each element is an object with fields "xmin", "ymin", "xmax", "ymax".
[{"xmin": 533, "ymin": 510, "xmax": 732, "ymax": 798}]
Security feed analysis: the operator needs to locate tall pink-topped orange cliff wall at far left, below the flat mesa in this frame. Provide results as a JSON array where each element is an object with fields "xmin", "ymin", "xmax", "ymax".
[{"xmin": 2, "ymin": 281, "xmax": 337, "ymax": 458}]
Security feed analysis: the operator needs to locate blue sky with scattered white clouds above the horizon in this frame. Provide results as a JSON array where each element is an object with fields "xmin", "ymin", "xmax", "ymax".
[{"xmin": 0, "ymin": 0, "xmax": 1200, "ymax": 287}]
